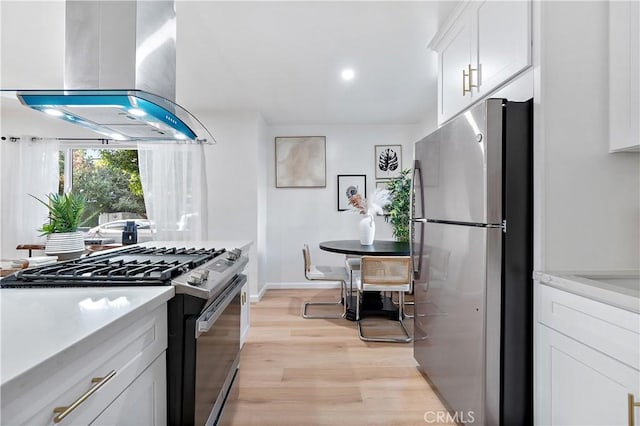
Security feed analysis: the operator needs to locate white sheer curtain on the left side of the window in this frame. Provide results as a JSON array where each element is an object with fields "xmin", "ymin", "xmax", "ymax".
[{"xmin": 0, "ymin": 136, "xmax": 60, "ymax": 260}]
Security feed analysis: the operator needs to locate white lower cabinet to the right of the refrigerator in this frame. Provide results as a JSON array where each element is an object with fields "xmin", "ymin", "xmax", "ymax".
[{"xmin": 535, "ymin": 283, "xmax": 640, "ymax": 426}]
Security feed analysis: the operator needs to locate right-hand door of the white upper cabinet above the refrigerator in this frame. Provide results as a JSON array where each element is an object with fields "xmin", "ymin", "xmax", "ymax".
[{"xmin": 472, "ymin": 1, "xmax": 531, "ymax": 96}]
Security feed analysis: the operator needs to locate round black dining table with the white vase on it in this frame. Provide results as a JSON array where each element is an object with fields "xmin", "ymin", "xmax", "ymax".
[{"xmin": 320, "ymin": 240, "xmax": 410, "ymax": 321}]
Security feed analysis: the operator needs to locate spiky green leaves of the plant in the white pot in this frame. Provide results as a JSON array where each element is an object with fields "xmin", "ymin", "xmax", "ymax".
[{"xmin": 29, "ymin": 192, "xmax": 86, "ymax": 235}]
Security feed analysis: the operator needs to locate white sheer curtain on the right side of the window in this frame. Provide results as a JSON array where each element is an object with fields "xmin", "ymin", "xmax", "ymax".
[{"xmin": 138, "ymin": 142, "xmax": 208, "ymax": 241}]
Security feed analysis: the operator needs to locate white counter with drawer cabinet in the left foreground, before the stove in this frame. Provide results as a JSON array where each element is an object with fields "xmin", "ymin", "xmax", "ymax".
[{"xmin": 0, "ymin": 286, "xmax": 174, "ymax": 424}]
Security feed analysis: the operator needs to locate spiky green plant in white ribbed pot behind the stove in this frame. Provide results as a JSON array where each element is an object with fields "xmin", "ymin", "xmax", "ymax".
[{"xmin": 29, "ymin": 192, "xmax": 86, "ymax": 260}]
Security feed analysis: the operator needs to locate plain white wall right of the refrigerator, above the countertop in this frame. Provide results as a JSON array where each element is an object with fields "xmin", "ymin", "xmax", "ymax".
[{"xmin": 535, "ymin": 2, "xmax": 640, "ymax": 270}]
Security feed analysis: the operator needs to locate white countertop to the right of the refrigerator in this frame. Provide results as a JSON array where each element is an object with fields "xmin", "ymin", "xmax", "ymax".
[{"xmin": 533, "ymin": 270, "xmax": 640, "ymax": 313}]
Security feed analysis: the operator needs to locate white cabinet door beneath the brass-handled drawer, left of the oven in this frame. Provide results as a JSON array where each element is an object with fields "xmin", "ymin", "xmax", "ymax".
[{"xmin": 91, "ymin": 352, "xmax": 167, "ymax": 426}]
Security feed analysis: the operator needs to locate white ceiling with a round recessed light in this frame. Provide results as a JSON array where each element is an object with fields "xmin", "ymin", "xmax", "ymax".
[{"xmin": 176, "ymin": 1, "xmax": 456, "ymax": 124}]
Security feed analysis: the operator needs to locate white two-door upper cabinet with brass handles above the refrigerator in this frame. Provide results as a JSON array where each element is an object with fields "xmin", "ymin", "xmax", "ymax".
[{"xmin": 429, "ymin": 1, "xmax": 531, "ymax": 124}]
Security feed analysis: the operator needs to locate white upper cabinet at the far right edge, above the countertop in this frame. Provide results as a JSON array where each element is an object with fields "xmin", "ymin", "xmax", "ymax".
[{"xmin": 609, "ymin": 0, "xmax": 640, "ymax": 152}]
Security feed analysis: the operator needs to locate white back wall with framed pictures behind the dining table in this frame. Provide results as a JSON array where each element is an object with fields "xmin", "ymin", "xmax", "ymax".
[{"xmin": 265, "ymin": 125, "xmax": 424, "ymax": 283}]
